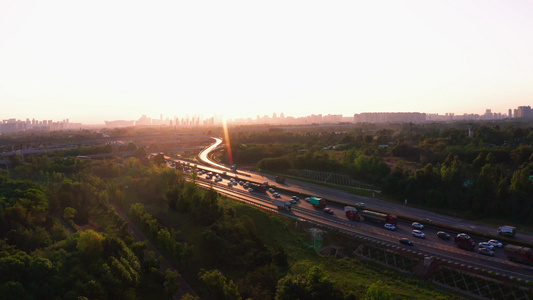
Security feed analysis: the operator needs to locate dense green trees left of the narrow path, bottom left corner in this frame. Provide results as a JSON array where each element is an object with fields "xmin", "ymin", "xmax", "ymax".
[{"xmin": 0, "ymin": 157, "xmax": 177, "ymax": 299}]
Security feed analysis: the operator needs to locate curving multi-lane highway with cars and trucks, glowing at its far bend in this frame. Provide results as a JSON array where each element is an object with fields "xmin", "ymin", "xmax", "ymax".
[{"xmin": 172, "ymin": 139, "xmax": 533, "ymax": 280}]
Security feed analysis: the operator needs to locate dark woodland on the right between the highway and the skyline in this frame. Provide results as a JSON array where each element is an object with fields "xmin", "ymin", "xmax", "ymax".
[{"xmin": 222, "ymin": 123, "xmax": 533, "ymax": 223}]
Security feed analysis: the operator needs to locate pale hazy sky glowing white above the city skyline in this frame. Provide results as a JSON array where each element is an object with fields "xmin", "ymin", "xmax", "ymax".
[{"xmin": 0, "ymin": 0, "xmax": 533, "ymax": 123}]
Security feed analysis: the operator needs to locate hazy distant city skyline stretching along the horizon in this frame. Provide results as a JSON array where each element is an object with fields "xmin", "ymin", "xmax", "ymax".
[{"xmin": 0, "ymin": 106, "xmax": 533, "ymax": 134}]
